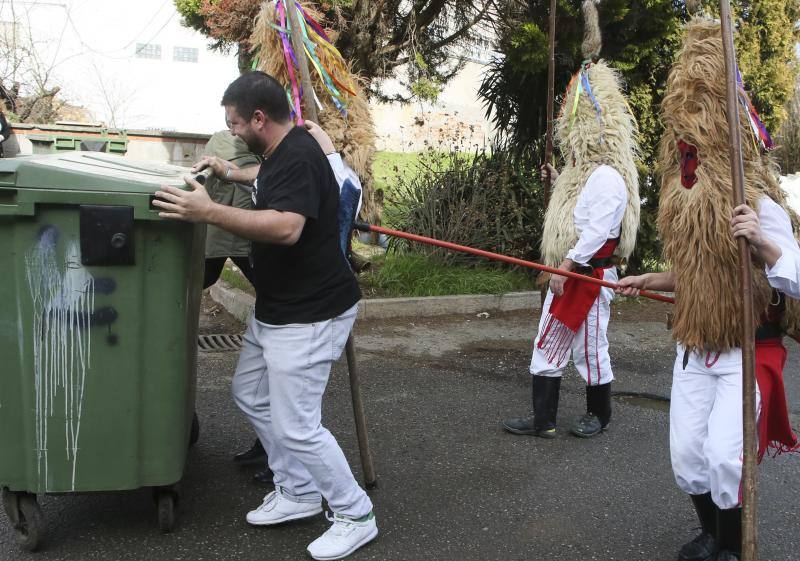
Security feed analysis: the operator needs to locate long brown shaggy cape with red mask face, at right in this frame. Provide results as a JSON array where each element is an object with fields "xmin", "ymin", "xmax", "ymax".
[{"xmin": 658, "ymin": 17, "xmax": 798, "ymax": 351}]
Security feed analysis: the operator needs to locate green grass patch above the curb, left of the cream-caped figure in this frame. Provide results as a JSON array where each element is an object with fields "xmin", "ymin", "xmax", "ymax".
[{"xmin": 361, "ymin": 251, "xmax": 535, "ymax": 297}]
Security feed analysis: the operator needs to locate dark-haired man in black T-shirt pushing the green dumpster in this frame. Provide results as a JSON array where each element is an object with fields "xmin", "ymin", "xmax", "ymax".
[{"xmin": 154, "ymin": 72, "xmax": 378, "ymax": 559}]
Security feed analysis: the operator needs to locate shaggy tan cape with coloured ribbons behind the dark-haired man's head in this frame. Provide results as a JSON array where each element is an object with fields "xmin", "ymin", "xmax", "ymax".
[{"xmin": 250, "ymin": 0, "xmax": 379, "ymax": 222}]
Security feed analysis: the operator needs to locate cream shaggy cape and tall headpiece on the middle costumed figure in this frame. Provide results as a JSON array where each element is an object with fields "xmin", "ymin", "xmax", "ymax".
[{"xmin": 542, "ymin": 1, "xmax": 640, "ymax": 267}]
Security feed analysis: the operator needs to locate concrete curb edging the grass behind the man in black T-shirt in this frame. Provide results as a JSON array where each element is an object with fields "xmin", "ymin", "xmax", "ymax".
[{"xmin": 211, "ymin": 281, "xmax": 541, "ymax": 322}]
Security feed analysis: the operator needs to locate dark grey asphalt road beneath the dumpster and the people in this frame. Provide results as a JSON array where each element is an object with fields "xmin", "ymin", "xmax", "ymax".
[{"xmin": 0, "ymin": 303, "xmax": 800, "ymax": 561}]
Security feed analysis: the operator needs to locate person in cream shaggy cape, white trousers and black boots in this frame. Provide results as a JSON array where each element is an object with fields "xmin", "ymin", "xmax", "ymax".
[{"xmin": 501, "ymin": 0, "xmax": 639, "ymax": 438}]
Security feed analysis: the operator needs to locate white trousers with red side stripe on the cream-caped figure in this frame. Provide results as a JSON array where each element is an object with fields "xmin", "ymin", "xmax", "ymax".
[{"xmin": 530, "ymin": 267, "xmax": 619, "ymax": 386}]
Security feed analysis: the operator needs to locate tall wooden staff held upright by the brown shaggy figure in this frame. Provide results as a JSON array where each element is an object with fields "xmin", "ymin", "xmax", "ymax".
[{"xmin": 719, "ymin": 0, "xmax": 758, "ymax": 561}]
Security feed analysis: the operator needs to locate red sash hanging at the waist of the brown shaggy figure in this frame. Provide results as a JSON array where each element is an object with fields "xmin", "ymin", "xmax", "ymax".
[{"xmin": 756, "ymin": 338, "xmax": 800, "ymax": 462}]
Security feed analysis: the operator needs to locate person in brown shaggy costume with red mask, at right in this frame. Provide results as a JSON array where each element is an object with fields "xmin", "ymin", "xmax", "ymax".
[{"xmin": 620, "ymin": 16, "xmax": 800, "ymax": 561}]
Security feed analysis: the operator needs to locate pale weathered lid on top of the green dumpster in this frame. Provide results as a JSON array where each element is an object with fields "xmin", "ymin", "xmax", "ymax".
[{"xmin": 0, "ymin": 152, "xmax": 198, "ymax": 193}]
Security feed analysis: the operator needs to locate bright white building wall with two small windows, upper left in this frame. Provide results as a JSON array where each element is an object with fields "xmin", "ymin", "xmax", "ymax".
[{"xmin": 0, "ymin": 0, "xmax": 238, "ymax": 133}]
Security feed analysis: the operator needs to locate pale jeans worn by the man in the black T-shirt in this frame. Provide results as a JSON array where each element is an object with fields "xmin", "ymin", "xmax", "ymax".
[{"xmin": 228, "ymin": 306, "xmax": 372, "ymax": 518}]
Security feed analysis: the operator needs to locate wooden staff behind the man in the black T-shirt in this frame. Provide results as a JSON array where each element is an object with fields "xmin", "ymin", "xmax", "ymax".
[{"xmin": 286, "ymin": 0, "xmax": 378, "ymax": 489}]
